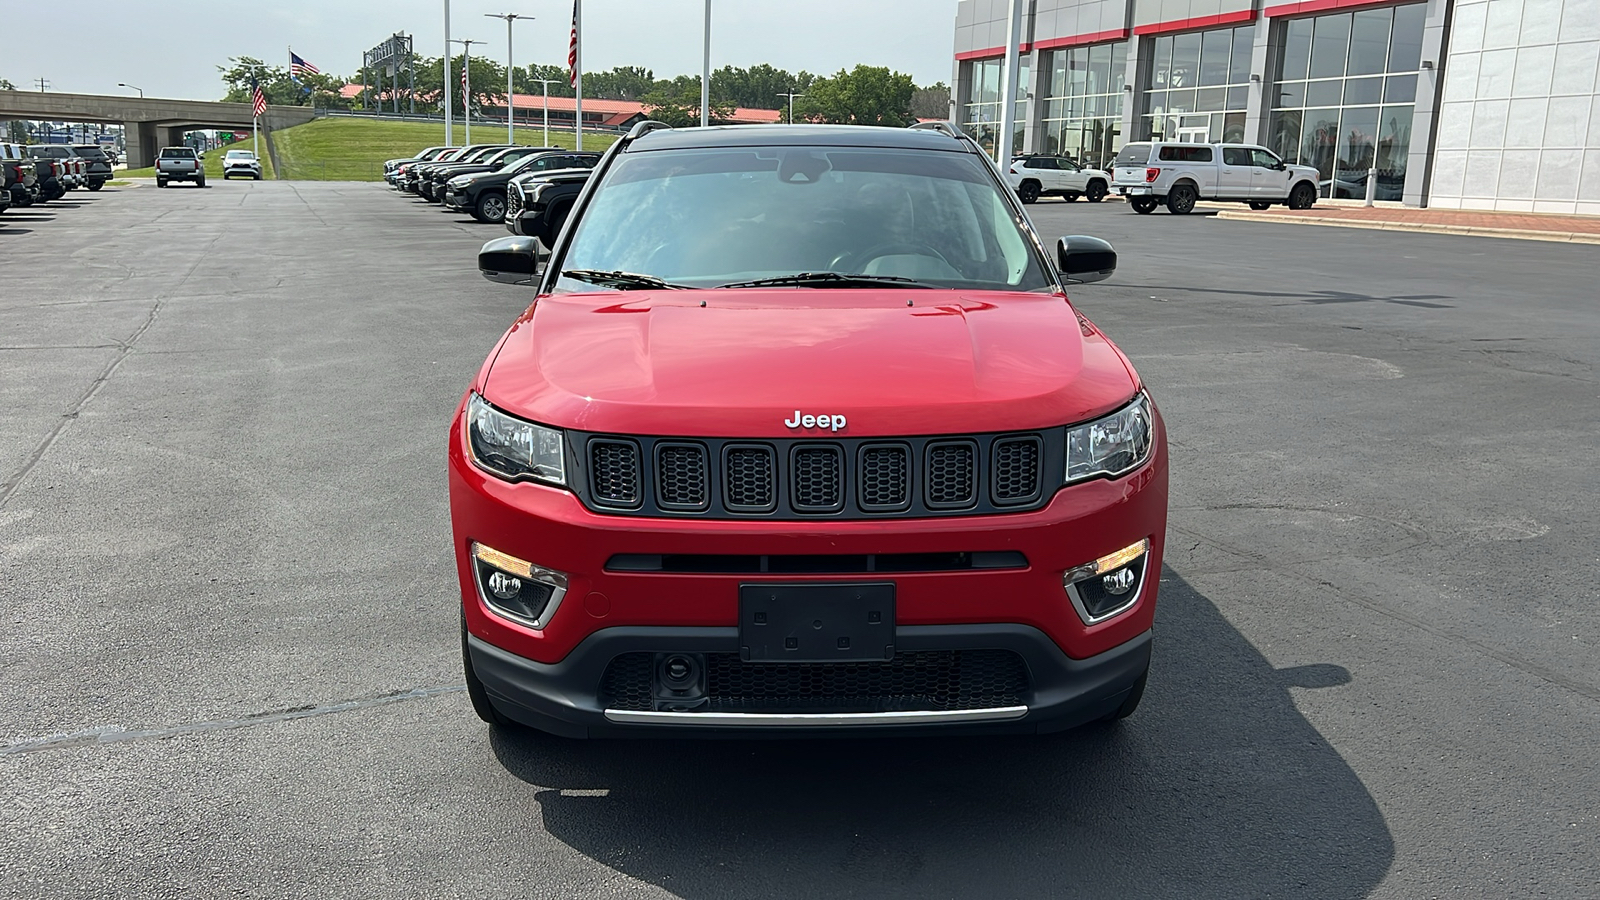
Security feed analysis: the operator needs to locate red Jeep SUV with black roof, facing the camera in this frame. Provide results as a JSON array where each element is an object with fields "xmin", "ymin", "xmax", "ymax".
[{"xmin": 450, "ymin": 122, "xmax": 1166, "ymax": 737}]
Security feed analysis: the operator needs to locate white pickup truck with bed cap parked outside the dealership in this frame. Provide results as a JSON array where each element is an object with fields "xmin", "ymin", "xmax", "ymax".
[{"xmin": 1112, "ymin": 141, "xmax": 1318, "ymax": 216}]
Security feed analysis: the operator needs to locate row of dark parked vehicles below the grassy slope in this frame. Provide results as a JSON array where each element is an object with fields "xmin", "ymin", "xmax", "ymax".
[{"xmin": 384, "ymin": 144, "xmax": 600, "ymax": 222}]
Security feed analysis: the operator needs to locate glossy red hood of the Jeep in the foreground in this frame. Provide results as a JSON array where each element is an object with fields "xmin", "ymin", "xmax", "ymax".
[{"xmin": 483, "ymin": 288, "xmax": 1134, "ymax": 437}]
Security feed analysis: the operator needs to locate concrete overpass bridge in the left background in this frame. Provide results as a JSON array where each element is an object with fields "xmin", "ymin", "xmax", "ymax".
[{"xmin": 0, "ymin": 91, "xmax": 312, "ymax": 168}]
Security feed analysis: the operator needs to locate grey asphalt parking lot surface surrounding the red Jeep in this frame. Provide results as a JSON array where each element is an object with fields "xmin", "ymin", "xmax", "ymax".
[{"xmin": 0, "ymin": 181, "xmax": 1600, "ymax": 898}]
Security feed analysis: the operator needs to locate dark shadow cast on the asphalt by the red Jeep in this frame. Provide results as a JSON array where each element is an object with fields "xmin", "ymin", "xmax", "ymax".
[{"xmin": 493, "ymin": 570, "xmax": 1394, "ymax": 898}]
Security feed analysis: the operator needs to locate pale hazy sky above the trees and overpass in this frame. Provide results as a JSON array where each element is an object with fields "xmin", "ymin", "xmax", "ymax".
[{"xmin": 0, "ymin": 0, "xmax": 957, "ymax": 99}]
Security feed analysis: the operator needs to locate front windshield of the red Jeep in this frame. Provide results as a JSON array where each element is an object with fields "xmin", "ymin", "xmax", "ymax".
[{"xmin": 555, "ymin": 147, "xmax": 1053, "ymax": 291}]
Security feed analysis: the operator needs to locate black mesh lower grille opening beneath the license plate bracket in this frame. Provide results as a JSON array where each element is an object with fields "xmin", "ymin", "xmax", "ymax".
[{"xmin": 600, "ymin": 650, "xmax": 1029, "ymax": 713}]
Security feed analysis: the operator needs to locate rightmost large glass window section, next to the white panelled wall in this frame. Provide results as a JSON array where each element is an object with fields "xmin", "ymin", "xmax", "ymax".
[{"xmin": 1269, "ymin": 3, "xmax": 1424, "ymax": 200}]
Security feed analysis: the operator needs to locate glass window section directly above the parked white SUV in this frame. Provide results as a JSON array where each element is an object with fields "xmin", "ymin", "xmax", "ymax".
[{"xmin": 1038, "ymin": 42, "xmax": 1132, "ymax": 168}]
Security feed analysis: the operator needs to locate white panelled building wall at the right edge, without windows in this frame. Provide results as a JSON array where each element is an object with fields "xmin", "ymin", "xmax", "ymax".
[{"xmin": 1429, "ymin": 0, "xmax": 1600, "ymax": 215}]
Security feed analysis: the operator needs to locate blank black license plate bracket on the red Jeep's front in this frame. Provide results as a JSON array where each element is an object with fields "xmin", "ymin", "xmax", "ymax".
[{"xmin": 739, "ymin": 581, "xmax": 894, "ymax": 663}]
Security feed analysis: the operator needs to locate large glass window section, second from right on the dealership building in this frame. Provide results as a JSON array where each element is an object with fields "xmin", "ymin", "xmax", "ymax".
[{"xmin": 1139, "ymin": 24, "xmax": 1256, "ymax": 141}]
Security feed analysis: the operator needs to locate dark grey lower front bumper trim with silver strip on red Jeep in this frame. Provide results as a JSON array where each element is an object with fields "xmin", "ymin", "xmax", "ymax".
[{"xmin": 467, "ymin": 625, "xmax": 1150, "ymax": 738}]
